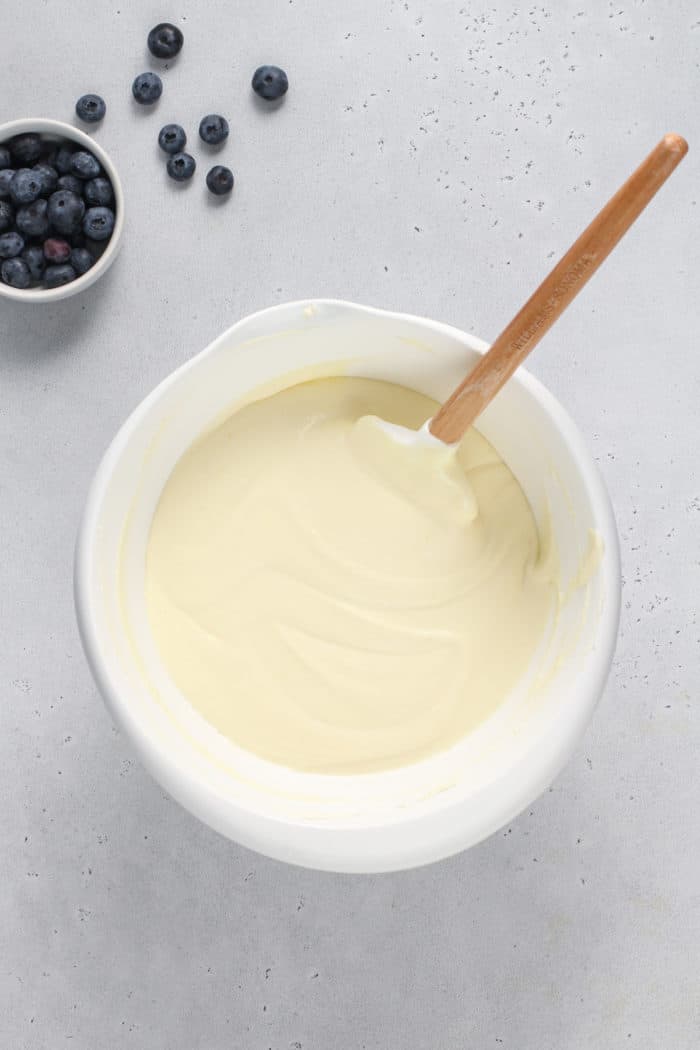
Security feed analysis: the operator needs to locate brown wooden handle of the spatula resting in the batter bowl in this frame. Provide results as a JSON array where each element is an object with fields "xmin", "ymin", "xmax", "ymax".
[{"xmin": 430, "ymin": 134, "xmax": 687, "ymax": 443}]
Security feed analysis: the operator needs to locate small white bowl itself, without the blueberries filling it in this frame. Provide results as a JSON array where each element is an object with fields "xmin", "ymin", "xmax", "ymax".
[{"xmin": 0, "ymin": 117, "xmax": 124, "ymax": 303}]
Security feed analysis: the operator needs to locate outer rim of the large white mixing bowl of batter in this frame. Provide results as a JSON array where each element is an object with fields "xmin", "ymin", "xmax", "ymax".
[{"xmin": 75, "ymin": 298, "xmax": 621, "ymax": 873}]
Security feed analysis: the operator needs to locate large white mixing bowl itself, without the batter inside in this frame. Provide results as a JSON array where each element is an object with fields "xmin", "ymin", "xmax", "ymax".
[{"xmin": 76, "ymin": 300, "xmax": 620, "ymax": 872}]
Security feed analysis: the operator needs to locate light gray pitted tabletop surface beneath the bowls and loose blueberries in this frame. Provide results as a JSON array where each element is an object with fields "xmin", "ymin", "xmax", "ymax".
[{"xmin": 0, "ymin": 0, "xmax": 700, "ymax": 1050}]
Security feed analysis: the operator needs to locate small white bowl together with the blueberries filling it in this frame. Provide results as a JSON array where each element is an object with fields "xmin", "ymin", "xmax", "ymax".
[{"xmin": 0, "ymin": 118, "xmax": 124, "ymax": 302}]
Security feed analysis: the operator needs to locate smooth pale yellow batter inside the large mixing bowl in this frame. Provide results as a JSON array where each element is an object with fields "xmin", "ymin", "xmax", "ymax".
[{"xmin": 147, "ymin": 378, "xmax": 556, "ymax": 774}]
